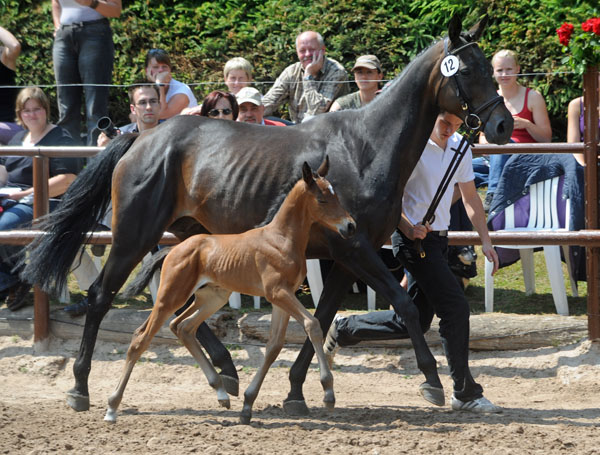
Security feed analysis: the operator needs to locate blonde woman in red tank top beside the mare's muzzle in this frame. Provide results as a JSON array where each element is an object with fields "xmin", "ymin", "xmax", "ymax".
[{"xmin": 479, "ymin": 49, "xmax": 552, "ymax": 209}]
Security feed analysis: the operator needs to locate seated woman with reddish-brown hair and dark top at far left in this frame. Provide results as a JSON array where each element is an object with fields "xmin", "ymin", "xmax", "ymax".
[{"xmin": 0, "ymin": 87, "xmax": 82, "ymax": 311}]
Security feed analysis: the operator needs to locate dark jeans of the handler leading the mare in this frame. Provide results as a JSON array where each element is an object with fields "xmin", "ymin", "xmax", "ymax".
[{"xmin": 338, "ymin": 232, "xmax": 483, "ymax": 401}]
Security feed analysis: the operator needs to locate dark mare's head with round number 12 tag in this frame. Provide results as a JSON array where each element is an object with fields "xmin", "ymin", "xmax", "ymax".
[{"xmin": 436, "ymin": 16, "xmax": 513, "ymax": 144}]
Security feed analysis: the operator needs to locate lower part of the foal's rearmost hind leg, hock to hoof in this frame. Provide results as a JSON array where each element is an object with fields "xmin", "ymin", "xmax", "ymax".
[{"xmin": 104, "ymin": 305, "xmax": 175, "ymax": 423}]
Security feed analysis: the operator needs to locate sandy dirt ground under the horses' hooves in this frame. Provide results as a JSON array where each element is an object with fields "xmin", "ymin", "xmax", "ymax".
[{"xmin": 0, "ymin": 336, "xmax": 600, "ymax": 455}]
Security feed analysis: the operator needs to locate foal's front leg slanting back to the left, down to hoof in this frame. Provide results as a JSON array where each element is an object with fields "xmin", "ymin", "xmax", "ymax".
[{"xmin": 240, "ymin": 306, "xmax": 290, "ymax": 425}]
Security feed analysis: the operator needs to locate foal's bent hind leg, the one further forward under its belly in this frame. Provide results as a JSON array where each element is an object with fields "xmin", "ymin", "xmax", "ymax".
[{"xmin": 171, "ymin": 285, "xmax": 231, "ymax": 409}]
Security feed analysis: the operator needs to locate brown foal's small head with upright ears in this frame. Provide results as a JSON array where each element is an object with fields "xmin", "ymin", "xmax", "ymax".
[{"xmin": 302, "ymin": 156, "xmax": 356, "ymax": 238}]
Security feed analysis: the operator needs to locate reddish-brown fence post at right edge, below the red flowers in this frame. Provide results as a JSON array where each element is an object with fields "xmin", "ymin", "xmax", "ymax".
[{"xmin": 583, "ymin": 67, "xmax": 600, "ymax": 340}]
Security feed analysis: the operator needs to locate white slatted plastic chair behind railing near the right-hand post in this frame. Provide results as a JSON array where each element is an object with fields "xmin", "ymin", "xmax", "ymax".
[{"xmin": 485, "ymin": 177, "xmax": 577, "ymax": 316}]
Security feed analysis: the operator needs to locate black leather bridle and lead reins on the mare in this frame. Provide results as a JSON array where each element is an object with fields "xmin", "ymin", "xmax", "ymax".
[{"xmin": 414, "ymin": 38, "xmax": 504, "ymax": 258}]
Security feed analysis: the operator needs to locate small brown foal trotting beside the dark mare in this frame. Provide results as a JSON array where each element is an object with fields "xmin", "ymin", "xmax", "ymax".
[{"xmin": 104, "ymin": 157, "xmax": 356, "ymax": 423}]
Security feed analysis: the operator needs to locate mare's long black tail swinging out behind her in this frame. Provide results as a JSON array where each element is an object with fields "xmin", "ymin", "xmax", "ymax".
[{"xmin": 17, "ymin": 134, "xmax": 138, "ymax": 292}]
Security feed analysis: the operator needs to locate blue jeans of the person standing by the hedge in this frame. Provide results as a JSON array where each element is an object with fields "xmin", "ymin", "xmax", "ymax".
[{"xmin": 52, "ymin": 19, "xmax": 115, "ymax": 145}]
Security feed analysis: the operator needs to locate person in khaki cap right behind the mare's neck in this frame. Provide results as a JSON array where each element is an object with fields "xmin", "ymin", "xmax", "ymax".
[{"xmin": 329, "ymin": 55, "xmax": 383, "ymax": 112}]
